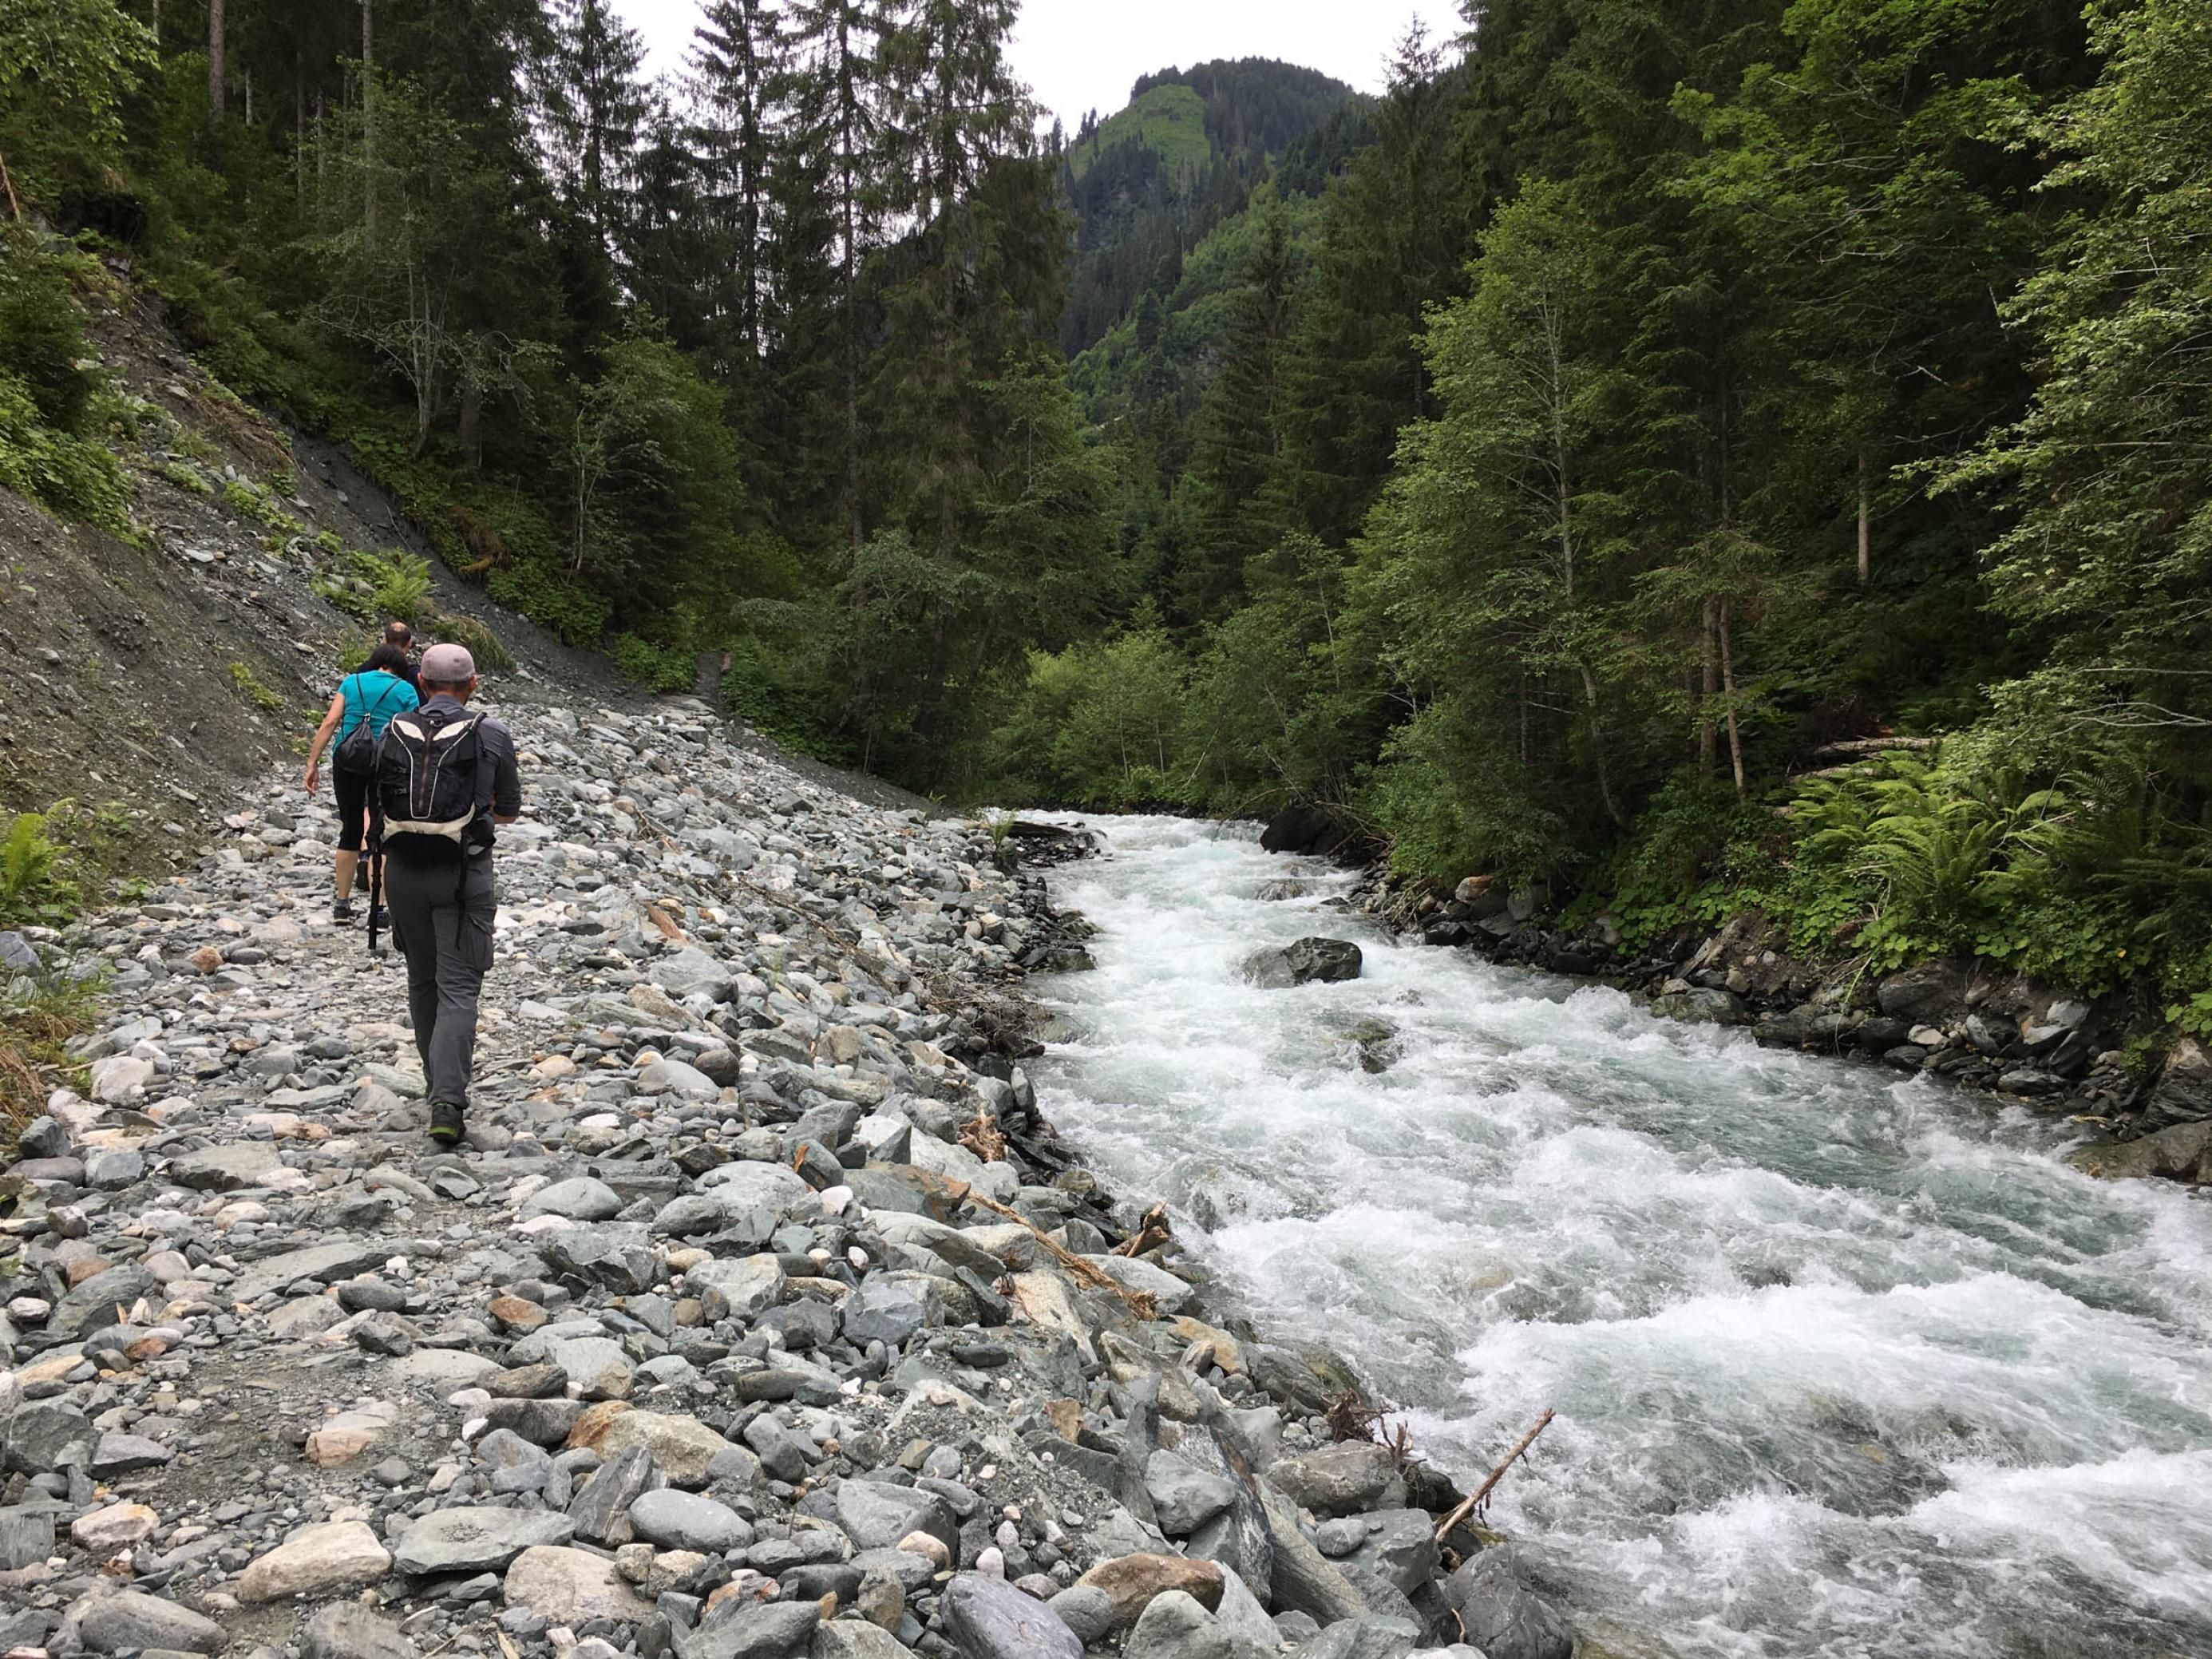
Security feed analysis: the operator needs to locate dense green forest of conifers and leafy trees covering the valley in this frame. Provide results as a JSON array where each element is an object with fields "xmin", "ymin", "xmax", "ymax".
[{"xmin": 0, "ymin": 0, "xmax": 2212, "ymax": 1028}]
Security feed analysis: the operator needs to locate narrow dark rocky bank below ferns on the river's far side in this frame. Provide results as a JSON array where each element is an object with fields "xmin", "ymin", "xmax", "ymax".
[{"xmin": 1354, "ymin": 872, "xmax": 2212, "ymax": 1183}]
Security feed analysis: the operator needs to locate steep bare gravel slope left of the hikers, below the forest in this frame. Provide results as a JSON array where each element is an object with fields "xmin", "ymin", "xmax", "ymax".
[{"xmin": 0, "ymin": 285, "xmax": 927, "ymax": 872}]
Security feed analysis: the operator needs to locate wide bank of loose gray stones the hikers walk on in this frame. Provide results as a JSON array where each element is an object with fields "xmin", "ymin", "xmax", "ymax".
[{"xmin": 0, "ymin": 675, "xmax": 1573, "ymax": 1659}]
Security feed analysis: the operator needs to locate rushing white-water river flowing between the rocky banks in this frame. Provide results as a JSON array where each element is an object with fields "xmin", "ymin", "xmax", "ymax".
[{"xmin": 1039, "ymin": 818, "xmax": 2212, "ymax": 1659}]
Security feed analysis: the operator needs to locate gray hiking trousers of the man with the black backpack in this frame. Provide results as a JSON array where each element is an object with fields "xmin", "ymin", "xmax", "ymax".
[{"xmin": 385, "ymin": 852, "xmax": 497, "ymax": 1106}]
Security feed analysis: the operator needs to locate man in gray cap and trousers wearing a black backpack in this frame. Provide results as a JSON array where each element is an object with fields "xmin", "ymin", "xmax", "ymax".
[{"xmin": 372, "ymin": 646, "xmax": 522, "ymax": 1146}]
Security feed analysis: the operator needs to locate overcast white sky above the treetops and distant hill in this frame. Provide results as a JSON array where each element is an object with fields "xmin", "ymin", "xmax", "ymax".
[{"xmin": 617, "ymin": 0, "xmax": 1462, "ymax": 130}]
